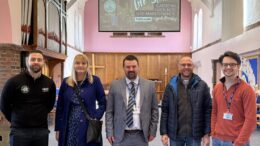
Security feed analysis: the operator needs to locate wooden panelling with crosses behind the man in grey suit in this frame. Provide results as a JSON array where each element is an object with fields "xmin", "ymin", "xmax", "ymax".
[{"xmin": 85, "ymin": 53, "xmax": 191, "ymax": 99}]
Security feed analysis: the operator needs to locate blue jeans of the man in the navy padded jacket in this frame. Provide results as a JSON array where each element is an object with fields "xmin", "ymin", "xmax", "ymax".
[{"xmin": 170, "ymin": 136, "xmax": 201, "ymax": 146}]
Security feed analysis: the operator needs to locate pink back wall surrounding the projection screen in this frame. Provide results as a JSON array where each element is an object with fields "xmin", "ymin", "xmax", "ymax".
[{"xmin": 84, "ymin": 0, "xmax": 191, "ymax": 53}]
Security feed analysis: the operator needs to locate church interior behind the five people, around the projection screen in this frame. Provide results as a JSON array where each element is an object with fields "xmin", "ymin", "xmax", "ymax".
[{"xmin": 0, "ymin": 0, "xmax": 260, "ymax": 146}]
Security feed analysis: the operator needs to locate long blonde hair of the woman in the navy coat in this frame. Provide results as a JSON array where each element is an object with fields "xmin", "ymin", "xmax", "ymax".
[{"xmin": 66, "ymin": 54, "xmax": 93, "ymax": 87}]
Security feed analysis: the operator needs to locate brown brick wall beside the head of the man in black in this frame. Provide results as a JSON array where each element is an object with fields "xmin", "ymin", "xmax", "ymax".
[{"xmin": 0, "ymin": 44, "xmax": 23, "ymax": 95}]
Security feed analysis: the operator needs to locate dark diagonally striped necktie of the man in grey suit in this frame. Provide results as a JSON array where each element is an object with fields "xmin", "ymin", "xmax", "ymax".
[{"xmin": 126, "ymin": 82, "xmax": 136, "ymax": 128}]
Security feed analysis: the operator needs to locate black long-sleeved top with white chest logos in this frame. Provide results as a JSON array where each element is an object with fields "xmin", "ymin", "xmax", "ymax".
[{"xmin": 0, "ymin": 72, "xmax": 56, "ymax": 128}]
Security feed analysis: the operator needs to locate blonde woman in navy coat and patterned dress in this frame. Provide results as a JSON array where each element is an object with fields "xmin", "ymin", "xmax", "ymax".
[{"xmin": 55, "ymin": 54, "xmax": 106, "ymax": 146}]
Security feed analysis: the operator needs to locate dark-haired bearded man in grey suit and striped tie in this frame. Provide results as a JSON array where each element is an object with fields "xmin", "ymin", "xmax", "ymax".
[{"xmin": 106, "ymin": 55, "xmax": 159, "ymax": 146}]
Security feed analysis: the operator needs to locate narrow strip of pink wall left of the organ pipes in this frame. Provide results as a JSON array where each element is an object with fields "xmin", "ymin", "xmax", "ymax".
[{"xmin": 0, "ymin": 0, "xmax": 12, "ymax": 43}]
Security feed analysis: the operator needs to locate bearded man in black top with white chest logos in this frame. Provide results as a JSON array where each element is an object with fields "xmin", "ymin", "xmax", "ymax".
[{"xmin": 0, "ymin": 50, "xmax": 56, "ymax": 146}]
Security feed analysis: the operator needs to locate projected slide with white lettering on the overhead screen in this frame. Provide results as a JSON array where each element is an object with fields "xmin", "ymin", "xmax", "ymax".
[{"xmin": 99, "ymin": 0, "xmax": 180, "ymax": 32}]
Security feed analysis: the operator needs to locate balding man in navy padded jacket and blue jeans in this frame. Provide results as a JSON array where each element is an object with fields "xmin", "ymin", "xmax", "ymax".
[{"xmin": 160, "ymin": 57, "xmax": 212, "ymax": 146}]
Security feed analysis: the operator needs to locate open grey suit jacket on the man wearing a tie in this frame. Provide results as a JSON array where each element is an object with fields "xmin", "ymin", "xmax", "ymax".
[{"xmin": 105, "ymin": 78, "xmax": 159, "ymax": 142}]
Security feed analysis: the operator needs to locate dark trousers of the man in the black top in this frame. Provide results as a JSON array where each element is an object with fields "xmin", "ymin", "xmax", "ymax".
[{"xmin": 10, "ymin": 128, "xmax": 50, "ymax": 146}]
